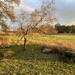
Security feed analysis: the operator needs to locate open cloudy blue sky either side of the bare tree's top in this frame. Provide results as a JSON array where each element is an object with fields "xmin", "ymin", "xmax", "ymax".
[{"xmin": 20, "ymin": 0, "xmax": 75, "ymax": 25}]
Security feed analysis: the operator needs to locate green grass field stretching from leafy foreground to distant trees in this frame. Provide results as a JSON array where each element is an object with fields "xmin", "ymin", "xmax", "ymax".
[{"xmin": 0, "ymin": 35, "xmax": 75, "ymax": 75}]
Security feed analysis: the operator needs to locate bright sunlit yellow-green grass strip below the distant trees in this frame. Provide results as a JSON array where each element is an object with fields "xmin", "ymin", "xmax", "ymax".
[{"xmin": 27, "ymin": 35, "xmax": 75, "ymax": 43}]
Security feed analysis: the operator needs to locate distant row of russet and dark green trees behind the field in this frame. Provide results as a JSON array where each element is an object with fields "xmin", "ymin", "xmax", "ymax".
[{"xmin": 16, "ymin": 23, "xmax": 75, "ymax": 35}]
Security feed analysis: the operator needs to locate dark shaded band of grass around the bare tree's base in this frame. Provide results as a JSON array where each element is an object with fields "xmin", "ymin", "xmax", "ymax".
[{"xmin": 1, "ymin": 44, "xmax": 75, "ymax": 62}]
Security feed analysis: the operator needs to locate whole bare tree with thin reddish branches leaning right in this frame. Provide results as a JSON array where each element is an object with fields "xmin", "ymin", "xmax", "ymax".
[{"xmin": 17, "ymin": 0, "xmax": 56, "ymax": 50}]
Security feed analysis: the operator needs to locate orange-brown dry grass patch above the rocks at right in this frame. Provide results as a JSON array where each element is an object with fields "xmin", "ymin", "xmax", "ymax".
[{"xmin": 41, "ymin": 41, "xmax": 75, "ymax": 52}]
